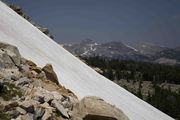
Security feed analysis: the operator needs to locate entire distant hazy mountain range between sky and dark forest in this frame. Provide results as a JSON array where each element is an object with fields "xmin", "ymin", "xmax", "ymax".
[{"xmin": 63, "ymin": 39, "xmax": 180, "ymax": 64}]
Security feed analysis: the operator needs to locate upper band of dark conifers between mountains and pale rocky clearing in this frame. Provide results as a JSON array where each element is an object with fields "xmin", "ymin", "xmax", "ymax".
[{"xmin": 82, "ymin": 57, "xmax": 180, "ymax": 84}]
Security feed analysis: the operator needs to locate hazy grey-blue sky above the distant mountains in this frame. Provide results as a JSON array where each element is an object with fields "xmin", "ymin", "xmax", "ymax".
[{"xmin": 4, "ymin": 0, "xmax": 180, "ymax": 47}]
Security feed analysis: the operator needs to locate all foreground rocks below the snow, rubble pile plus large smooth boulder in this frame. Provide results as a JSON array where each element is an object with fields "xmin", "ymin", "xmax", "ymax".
[{"xmin": 0, "ymin": 43, "xmax": 128, "ymax": 120}]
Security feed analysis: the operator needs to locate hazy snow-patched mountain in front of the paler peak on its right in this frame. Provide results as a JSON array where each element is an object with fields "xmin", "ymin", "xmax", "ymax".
[{"xmin": 63, "ymin": 39, "xmax": 148, "ymax": 61}]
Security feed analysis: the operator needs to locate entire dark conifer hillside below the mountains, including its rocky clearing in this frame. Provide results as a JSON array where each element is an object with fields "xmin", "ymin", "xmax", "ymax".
[{"xmin": 81, "ymin": 57, "xmax": 180, "ymax": 119}]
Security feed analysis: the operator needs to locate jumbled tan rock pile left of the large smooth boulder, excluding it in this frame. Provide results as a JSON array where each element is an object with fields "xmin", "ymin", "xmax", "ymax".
[{"xmin": 0, "ymin": 43, "xmax": 78, "ymax": 120}]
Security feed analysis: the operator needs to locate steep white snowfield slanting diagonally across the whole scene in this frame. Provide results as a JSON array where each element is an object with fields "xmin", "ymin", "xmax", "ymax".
[{"xmin": 0, "ymin": 2, "xmax": 172, "ymax": 120}]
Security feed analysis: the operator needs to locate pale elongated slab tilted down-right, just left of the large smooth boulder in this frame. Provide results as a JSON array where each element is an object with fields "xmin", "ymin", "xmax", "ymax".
[{"xmin": 51, "ymin": 100, "xmax": 69, "ymax": 118}]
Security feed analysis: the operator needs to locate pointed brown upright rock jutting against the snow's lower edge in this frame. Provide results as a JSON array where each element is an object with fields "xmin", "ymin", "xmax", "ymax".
[{"xmin": 42, "ymin": 64, "xmax": 59, "ymax": 85}]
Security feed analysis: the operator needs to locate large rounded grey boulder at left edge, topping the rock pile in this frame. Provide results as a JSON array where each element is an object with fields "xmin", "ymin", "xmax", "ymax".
[{"xmin": 0, "ymin": 42, "xmax": 21, "ymax": 68}]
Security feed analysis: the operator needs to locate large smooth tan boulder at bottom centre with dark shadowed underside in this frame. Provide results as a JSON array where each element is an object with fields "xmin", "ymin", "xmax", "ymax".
[{"xmin": 72, "ymin": 96, "xmax": 129, "ymax": 120}]
